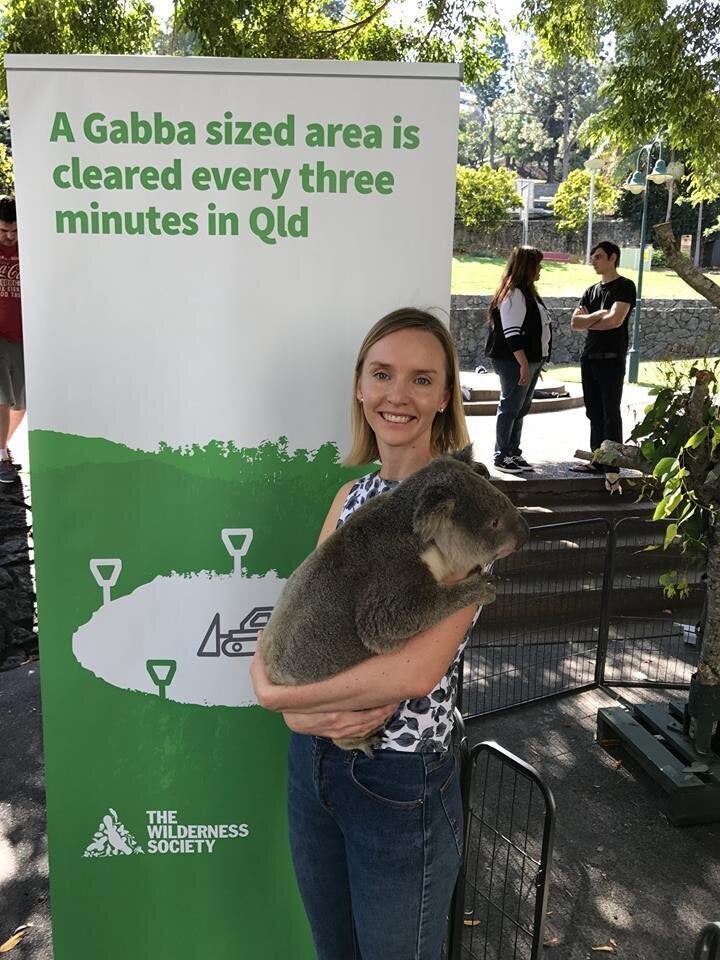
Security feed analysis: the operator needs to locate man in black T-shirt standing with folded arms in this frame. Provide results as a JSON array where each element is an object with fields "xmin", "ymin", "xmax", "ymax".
[{"xmin": 570, "ymin": 240, "xmax": 637, "ymax": 473}]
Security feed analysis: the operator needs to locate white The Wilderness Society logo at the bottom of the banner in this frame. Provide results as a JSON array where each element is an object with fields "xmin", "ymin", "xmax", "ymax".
[{"xmin": 83, "ymin": 807, "xmax": 250, "ymax": 859}]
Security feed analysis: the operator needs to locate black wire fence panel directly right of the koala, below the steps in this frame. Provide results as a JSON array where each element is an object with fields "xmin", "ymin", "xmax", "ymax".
[{"xmin": 458, "ymin": 519, "xmax": 614, "ymax": 719}]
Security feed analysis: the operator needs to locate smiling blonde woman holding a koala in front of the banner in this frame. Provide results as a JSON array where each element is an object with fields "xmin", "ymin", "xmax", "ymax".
[{"xmin": 252, "ymin": 309, "xmax": 476, "ymax": 960}]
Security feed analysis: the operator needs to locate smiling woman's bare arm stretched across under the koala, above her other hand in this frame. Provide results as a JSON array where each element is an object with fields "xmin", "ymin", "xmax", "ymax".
[{"xmin": 250, "ymin": 605, "xmax": 477, "ymax": 713}]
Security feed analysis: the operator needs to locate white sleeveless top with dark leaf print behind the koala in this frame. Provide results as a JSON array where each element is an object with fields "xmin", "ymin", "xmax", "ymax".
[{"xmin": 338, "ymin": 471, "xmax": 480, "ymax": 753}]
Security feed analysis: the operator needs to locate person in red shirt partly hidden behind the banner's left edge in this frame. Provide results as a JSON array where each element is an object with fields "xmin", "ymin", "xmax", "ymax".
[{"xmin": 0, "ymin": 197, "xmax": 25, "ymax": 483}]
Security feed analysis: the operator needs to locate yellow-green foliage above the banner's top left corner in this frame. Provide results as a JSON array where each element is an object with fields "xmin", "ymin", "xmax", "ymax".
[{"xmin": 0, "ymin": 0, "xmax": 157, "ymax": 97}]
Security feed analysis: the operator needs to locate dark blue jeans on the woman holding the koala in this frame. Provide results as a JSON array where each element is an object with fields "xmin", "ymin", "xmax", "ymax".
[{"xmin": 288, "ymin": 734, "xmax": 463, "ymax": 960}]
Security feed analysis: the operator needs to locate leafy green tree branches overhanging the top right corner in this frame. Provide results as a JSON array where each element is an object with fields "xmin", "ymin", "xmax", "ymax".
[{"xmin": 523, "ymin": 0, "xmax": 720, "ymax": 202}]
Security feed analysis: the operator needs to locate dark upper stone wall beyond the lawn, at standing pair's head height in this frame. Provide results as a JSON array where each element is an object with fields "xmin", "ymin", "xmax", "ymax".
[{"xmin": 453, "ymin": 217, "xmax": 640, "ymax": 260}]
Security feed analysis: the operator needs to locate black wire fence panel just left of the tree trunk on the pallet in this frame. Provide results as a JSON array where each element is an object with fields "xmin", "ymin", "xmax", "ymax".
[{"xmin": 600, "ymin": 517, "xmax": 705, "ymax": 688}]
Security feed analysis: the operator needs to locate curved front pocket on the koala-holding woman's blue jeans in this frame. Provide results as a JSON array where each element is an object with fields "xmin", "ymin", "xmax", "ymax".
[{"xmin": 350, "ymin": 750, "xmax": 425, "ymax": 810}]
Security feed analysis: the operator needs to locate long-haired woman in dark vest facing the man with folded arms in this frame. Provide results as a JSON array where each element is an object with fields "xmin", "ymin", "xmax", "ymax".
[{"xmin": 485, "ymin": 247, "xmax": 552, "ymax": 473}]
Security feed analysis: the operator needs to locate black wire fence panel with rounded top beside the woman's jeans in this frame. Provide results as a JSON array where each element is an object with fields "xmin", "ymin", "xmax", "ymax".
[{"xmin": 448, "ymin": 742, "xmax": 555, "ymax": 960}]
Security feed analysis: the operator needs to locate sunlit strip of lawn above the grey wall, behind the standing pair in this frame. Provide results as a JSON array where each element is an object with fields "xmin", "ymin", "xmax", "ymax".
[{"xmin": 452, "ymin": 257, "xmax": 718, "ymax": 300}]
